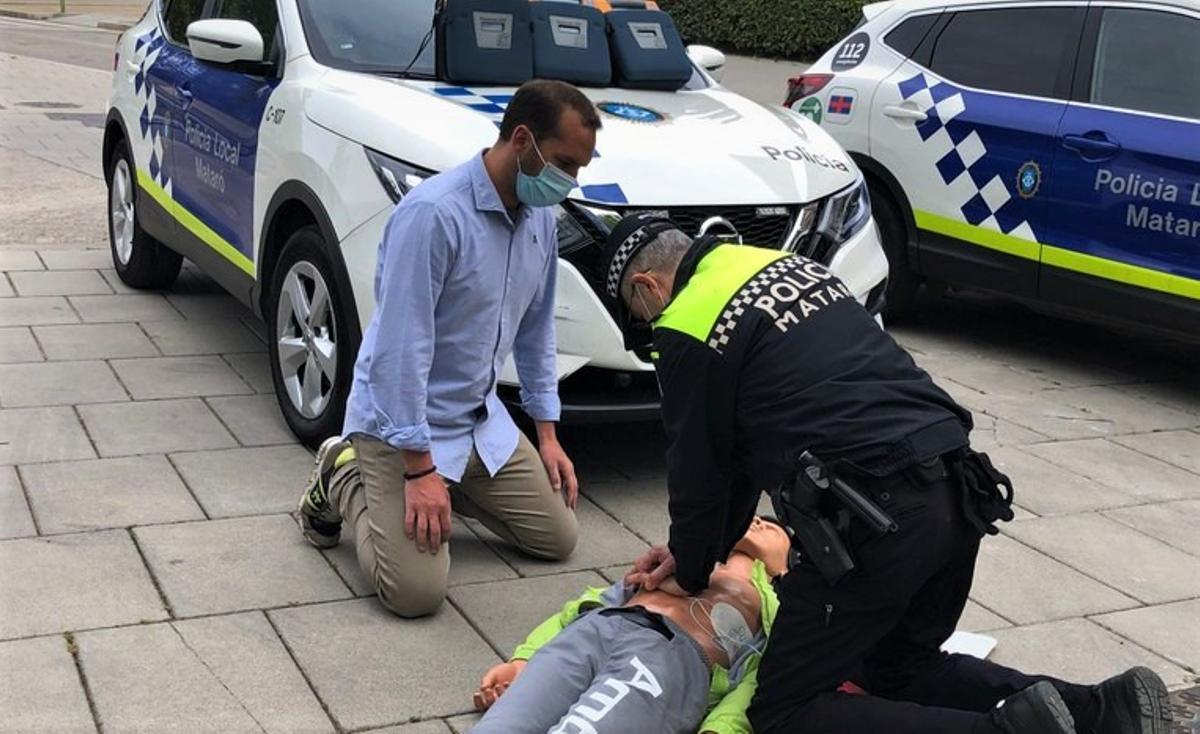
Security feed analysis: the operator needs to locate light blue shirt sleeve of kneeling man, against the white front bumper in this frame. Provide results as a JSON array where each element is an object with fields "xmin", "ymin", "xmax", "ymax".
[{"xmin": 512, "ymin": 227, "xmax": 563, "ymax": 421}]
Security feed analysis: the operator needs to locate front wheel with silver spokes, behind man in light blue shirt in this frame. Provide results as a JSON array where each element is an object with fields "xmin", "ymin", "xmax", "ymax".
[{"xmin": 263, "ymin": 225, "xmax": 361, "ymax": 446}]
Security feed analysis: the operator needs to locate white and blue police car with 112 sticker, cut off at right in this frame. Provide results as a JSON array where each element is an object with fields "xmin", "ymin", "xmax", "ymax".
[{"xmin": 787, "ymin": 0, "xmax": 1200, "ymax": 335}]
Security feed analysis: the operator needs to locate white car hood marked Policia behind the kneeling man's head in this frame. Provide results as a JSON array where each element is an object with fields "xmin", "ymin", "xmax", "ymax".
[{"xmin": 305, "ymin": 71, "xmax": 858, "ymax": 206}]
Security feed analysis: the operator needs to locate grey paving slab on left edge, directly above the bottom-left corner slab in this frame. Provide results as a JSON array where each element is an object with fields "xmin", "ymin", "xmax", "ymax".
[{"xmin": 0, "ymin": 530, "xmax": 167, "ymax": 639}]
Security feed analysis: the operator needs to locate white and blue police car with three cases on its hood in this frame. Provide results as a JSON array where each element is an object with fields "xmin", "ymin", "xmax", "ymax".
[{"xmin": 103, "ymin": 0, "xmax": 887, "ymax": 440}]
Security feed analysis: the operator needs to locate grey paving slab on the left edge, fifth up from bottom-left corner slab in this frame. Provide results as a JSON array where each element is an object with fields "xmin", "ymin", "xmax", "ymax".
[{"xmin": 0, "ymin": 361, "xmax": 130, "ymax": 408}]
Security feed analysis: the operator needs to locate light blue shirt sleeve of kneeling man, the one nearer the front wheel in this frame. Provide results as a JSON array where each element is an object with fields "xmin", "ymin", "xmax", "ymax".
[{"xmin": 368, "ymin": 201, "xmax": 455, "ymax": 451}]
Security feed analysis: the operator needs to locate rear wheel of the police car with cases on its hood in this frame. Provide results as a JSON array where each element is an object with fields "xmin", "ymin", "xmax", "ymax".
[{"xmin": 104, "ymin": 140, "xmax": 184, "ymax": 290}]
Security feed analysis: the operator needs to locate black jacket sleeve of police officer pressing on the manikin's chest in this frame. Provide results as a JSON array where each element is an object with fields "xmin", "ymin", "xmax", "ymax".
[{"xmin": 655, "ymin": 329, "xmax": 737, "ymax": 594}]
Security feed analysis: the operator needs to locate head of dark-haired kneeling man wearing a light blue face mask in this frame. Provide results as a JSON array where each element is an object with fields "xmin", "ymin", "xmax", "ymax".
[{"xmin": 486, "ymin": 79, "xmax": 601, "ymax": 209}]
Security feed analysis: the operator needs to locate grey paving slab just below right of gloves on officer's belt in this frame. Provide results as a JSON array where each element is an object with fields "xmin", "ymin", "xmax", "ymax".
[{"xmin": 1004, "ymin": 515, "xmax": 1200, "ymax": 604}]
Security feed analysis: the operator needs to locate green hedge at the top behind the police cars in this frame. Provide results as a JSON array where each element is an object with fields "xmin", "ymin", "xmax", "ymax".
[{"xmin": 659, "ymin": 0, "xmax": 866, "ymax": 61}]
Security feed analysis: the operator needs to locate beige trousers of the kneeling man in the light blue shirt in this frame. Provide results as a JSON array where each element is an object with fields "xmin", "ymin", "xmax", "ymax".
[{"xmin": 330, "ymin": 434, "xmax": 578, "ymax": 616}]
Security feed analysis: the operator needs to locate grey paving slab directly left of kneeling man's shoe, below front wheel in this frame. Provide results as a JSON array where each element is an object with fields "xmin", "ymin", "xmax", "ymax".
[{"xmin": 170, "ymin": 444, "xmax": 313, "ymax": 517}]
